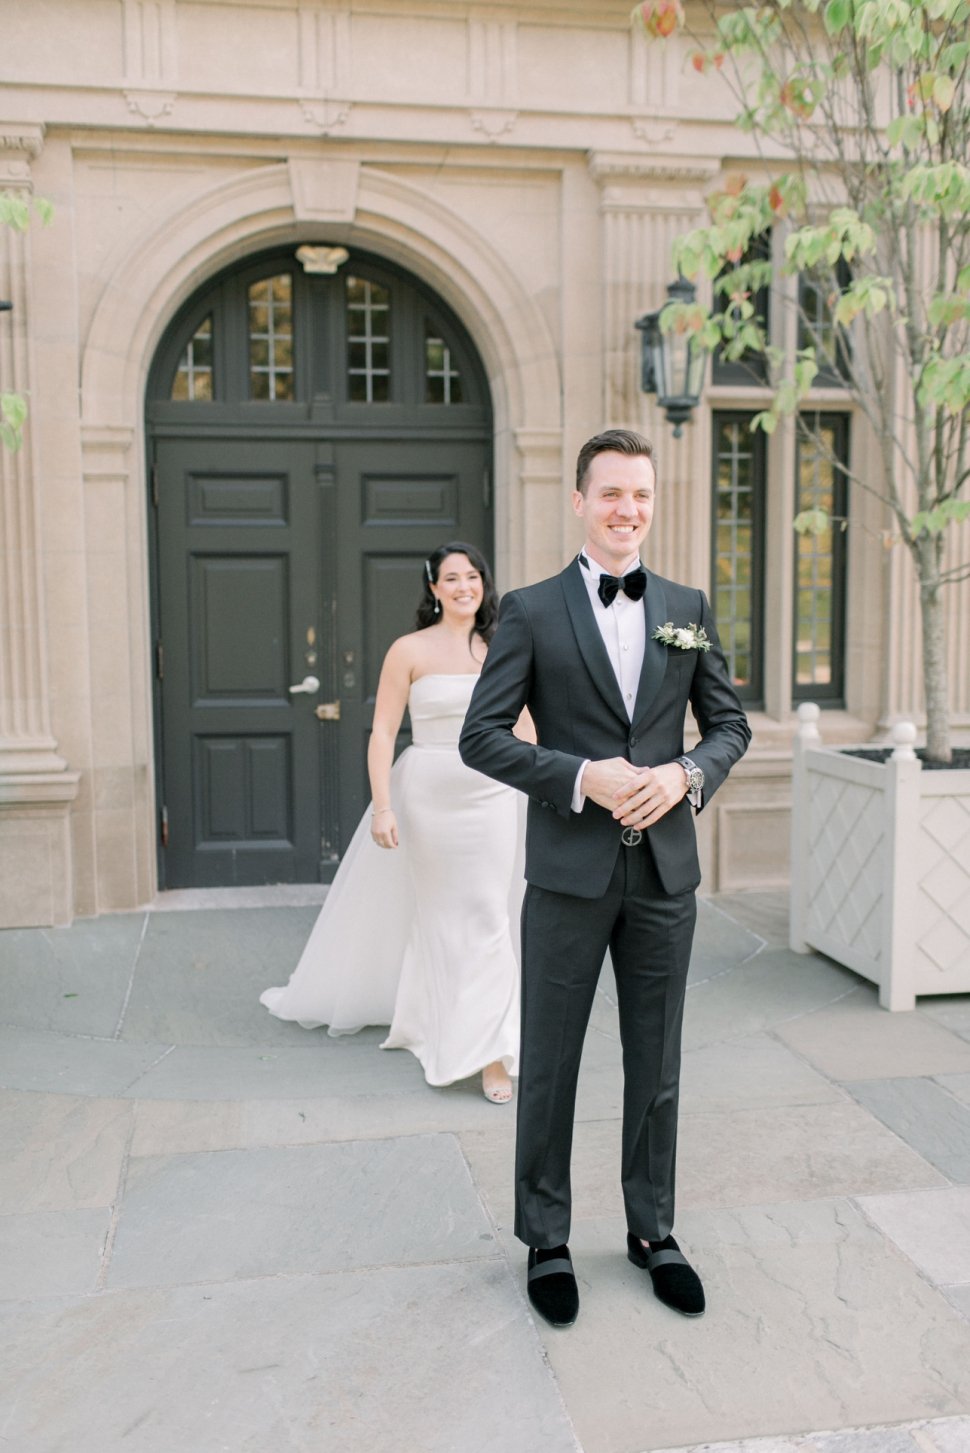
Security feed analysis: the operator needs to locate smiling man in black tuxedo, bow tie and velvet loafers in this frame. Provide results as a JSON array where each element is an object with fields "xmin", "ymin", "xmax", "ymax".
[{"xmin": 460, "ymin": 429, "xmax": 751, "ymax": 1327}]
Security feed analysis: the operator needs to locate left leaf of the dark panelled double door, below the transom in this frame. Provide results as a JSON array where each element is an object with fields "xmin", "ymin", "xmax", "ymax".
[{"xmin": 157, "ymin": 439, "xmax": 333, "ymax": 888}]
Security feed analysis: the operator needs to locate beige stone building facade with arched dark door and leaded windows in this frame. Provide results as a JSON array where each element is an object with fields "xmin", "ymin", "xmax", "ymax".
[{"xmin": 0, "ymin": 0, "xmax": 970, "ymax": 926}]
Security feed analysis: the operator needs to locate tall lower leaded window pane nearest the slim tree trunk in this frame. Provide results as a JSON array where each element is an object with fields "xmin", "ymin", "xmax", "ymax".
[{"xmin": 791, "ymin": 414, "xmax": 849, "ymax": 706}]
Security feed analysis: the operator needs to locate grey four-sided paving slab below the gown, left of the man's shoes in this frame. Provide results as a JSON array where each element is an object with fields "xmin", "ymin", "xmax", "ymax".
[{"xmin": 107, "ymin": 1135, "xmax": 495, "ymax": 1287}]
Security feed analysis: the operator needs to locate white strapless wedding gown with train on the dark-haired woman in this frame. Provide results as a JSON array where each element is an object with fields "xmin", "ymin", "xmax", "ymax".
[{"xmin": 260, "ymin": 674, "xmax": 524, "ymax": 1085}]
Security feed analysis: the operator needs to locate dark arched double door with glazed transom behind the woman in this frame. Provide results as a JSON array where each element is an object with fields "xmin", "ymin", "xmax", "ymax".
[{"xmin": 147, "ymin": 246, "xmax": 492, "ymax": 888}]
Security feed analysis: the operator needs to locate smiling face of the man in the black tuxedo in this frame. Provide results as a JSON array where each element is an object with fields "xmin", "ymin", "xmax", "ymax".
[{"xmin": 572, "ymin": 450, "xmax": 656, "ymax": 574}]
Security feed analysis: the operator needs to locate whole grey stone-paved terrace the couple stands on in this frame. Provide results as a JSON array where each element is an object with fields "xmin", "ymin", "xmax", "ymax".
[{"xmin": 0, "ymin": 889, "xmax": 970, "ymax": 1453}]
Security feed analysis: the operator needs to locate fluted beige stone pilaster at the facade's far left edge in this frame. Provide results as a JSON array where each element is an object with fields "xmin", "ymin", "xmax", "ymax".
[{"xmin": 0, "ymin": 125, "xmax": 78, "ymax": 927}]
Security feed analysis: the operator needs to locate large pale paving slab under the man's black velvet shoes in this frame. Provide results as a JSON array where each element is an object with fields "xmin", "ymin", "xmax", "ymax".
[{"xmin": 496, "ymin": 1200, "xmax": 970, "ymax": 1453}]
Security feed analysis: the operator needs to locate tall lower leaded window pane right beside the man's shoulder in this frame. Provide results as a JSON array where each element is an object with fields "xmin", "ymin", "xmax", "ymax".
[{"xmin": 712, "ymin": 413, "xmax": 765, "ymax": 706}]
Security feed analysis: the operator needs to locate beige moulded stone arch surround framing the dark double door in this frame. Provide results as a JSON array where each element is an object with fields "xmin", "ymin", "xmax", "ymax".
[{"xmin": 81, "ymin": 157, "xmax": 562, "ymax": 907}]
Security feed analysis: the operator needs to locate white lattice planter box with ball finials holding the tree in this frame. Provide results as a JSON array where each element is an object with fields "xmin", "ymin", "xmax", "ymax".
[{"xmin": 790, "ymin": 702, "xmax": 970, "ymax": 1010}]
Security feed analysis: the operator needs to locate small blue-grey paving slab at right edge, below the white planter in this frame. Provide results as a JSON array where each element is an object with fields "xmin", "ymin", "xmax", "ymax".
[{"xmin": 849, "ymin": 1078, "xmax": 970, "ymax": 1186}]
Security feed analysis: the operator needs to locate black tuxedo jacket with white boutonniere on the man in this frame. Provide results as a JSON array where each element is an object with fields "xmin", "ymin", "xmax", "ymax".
[{"xmin": 460, "ymin": 561, "xmax": 751, "ymax": 898}]
